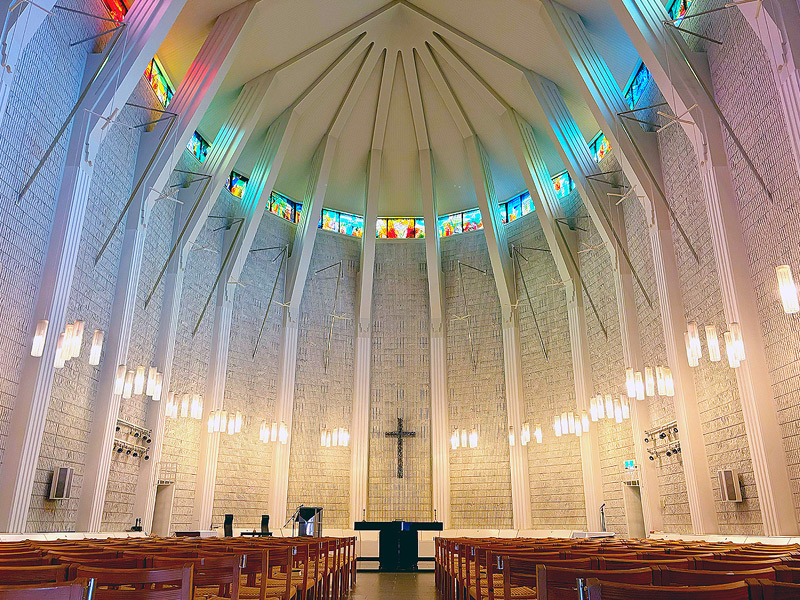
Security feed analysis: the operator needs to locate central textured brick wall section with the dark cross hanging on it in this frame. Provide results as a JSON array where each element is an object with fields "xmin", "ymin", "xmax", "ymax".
[{"xmin": 367, "ymin": 240, "xmax": 433, "ymax": 521}]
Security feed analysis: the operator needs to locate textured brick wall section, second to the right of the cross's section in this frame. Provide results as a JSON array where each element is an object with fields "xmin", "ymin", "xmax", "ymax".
[{"xmin": 507, "ymin": 213, "xmax": 586, "ymax": 529}]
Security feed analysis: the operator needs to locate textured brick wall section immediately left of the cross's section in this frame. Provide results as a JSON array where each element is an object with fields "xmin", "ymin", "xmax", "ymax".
[{"xmin": 287, "ymin": 231, "xmax": 361, "ymax": 527}]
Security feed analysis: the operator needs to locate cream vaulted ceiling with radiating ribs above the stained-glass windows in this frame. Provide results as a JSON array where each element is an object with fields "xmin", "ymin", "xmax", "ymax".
[{"xmin": 159, "ymin": 0, "xmax": 638, "ymax": 216}]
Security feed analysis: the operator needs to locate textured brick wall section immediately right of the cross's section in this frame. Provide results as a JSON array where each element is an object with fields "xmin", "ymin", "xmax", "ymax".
[{"xmin": 442, "ymin": 231, "xmax": 512, "ymax": 528}]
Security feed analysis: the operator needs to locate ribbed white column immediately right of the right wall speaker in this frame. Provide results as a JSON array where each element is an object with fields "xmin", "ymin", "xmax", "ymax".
[{"xmin": 610, "ymin": 0, "xmax": 800, "ymax": 535}]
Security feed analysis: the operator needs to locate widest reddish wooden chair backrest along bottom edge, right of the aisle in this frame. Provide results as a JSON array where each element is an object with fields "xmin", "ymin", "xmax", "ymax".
[{"xmin": 588, "ymin": 579, "xmax": 760, "ymax": 600}]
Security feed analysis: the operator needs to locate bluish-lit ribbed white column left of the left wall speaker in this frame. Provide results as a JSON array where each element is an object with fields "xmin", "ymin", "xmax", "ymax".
[{"xmin": 0, "ymin": 0, "xmax": 185, "ymax": 531}]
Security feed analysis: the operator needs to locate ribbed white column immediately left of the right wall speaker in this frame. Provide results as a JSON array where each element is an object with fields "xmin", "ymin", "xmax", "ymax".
[{"xmin": 542, "ymin": 0, "xmax": 718, "ymax": 533}]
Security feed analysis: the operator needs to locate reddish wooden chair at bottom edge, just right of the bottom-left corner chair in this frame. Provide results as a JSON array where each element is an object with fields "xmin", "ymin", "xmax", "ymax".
[{"xmin": 76, "ymin": 564, "xmax": 192, "ymax": 600}]
